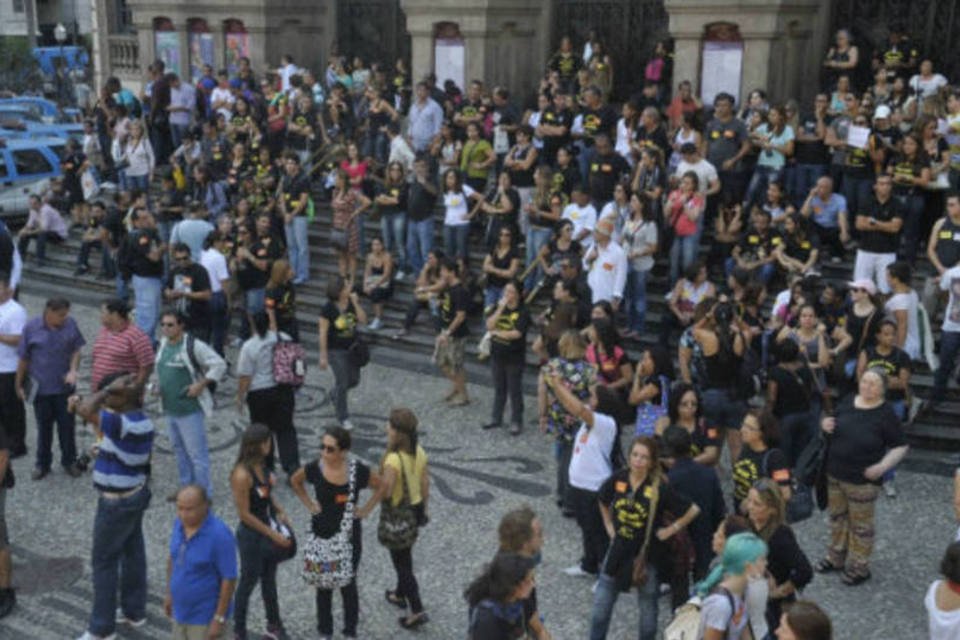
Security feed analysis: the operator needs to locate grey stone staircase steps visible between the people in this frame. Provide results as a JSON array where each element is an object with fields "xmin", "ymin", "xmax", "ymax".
[{"xmin": 22, "ymin": 202, "xmax": 960, "ymax": 470}]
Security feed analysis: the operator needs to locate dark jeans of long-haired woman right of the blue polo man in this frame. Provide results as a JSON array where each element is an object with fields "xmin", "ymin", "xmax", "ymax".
[{"xmin": 233, "ymin": 523, "xmax": 280, "ymax": 637}]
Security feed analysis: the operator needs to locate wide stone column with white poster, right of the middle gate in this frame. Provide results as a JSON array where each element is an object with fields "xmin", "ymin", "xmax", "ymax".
[{"xmin": 664, "ymin": 0, "xmax": 830, "ymax": 104}]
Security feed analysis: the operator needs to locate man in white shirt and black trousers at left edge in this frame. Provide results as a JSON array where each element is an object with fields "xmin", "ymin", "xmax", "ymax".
[{"xmin": 0, "ymin": 272, "xmax": 27, "ymax": 458}]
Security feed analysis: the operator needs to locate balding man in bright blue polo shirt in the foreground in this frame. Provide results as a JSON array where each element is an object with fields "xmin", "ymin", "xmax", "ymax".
[{"xmin": 163, "ymin": 484, "xmax": 237, "ymax": 640}]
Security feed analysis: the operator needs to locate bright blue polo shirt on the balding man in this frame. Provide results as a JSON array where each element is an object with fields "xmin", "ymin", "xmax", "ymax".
[{"xmin": 170, "ymin": 513, "xmax": 237, "ymax": 625}]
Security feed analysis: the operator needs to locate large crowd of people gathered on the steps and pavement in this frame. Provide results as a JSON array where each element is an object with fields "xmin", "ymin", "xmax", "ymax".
[{"xmin": 0, "ymin": 17, "xmax": 960, "ymax": 640}]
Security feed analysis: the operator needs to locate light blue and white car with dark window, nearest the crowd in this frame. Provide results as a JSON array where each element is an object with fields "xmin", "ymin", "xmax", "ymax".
[{"xmin": 0, "ymin": 138, "xmax": 66, "ymax": 220}]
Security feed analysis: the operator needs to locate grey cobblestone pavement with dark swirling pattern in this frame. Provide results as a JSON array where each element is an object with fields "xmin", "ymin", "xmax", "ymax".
[{"xmin": 0, "ymin": 297, "xmax": 955, "ymax": 640}]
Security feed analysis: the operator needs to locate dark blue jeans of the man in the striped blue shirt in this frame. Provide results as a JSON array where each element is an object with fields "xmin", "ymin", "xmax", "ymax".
[{"xmin": 87, "ymin": 486, "xmax": 150, "ymax": 636}]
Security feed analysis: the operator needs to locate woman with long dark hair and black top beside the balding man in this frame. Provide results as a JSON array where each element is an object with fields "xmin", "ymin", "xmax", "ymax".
[{"xmin": 230, "ymin": 422, "xmax": 292, "ymax": 639}]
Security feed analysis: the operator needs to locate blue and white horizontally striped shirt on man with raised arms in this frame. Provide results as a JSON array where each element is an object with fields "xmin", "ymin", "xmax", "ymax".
[{"xmin": 93, "ymin": 409, "xmax": 153, "ymax": 491}]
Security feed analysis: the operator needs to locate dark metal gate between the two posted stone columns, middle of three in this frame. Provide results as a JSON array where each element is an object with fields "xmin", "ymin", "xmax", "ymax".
[{"xmin": 553, "ymin": 0, "xmax": 669, "ymax": 100}]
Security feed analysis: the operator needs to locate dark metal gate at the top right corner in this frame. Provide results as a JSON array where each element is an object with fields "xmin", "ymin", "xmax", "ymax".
[{"xmin": 831, "ymin": 0, "xmax": 960, "ymax": 82}]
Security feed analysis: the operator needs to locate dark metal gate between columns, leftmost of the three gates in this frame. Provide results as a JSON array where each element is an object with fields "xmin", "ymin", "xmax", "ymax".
[{"xmin": 337, "ymin": 0, "xmax": 410, "ymax": 68}]
